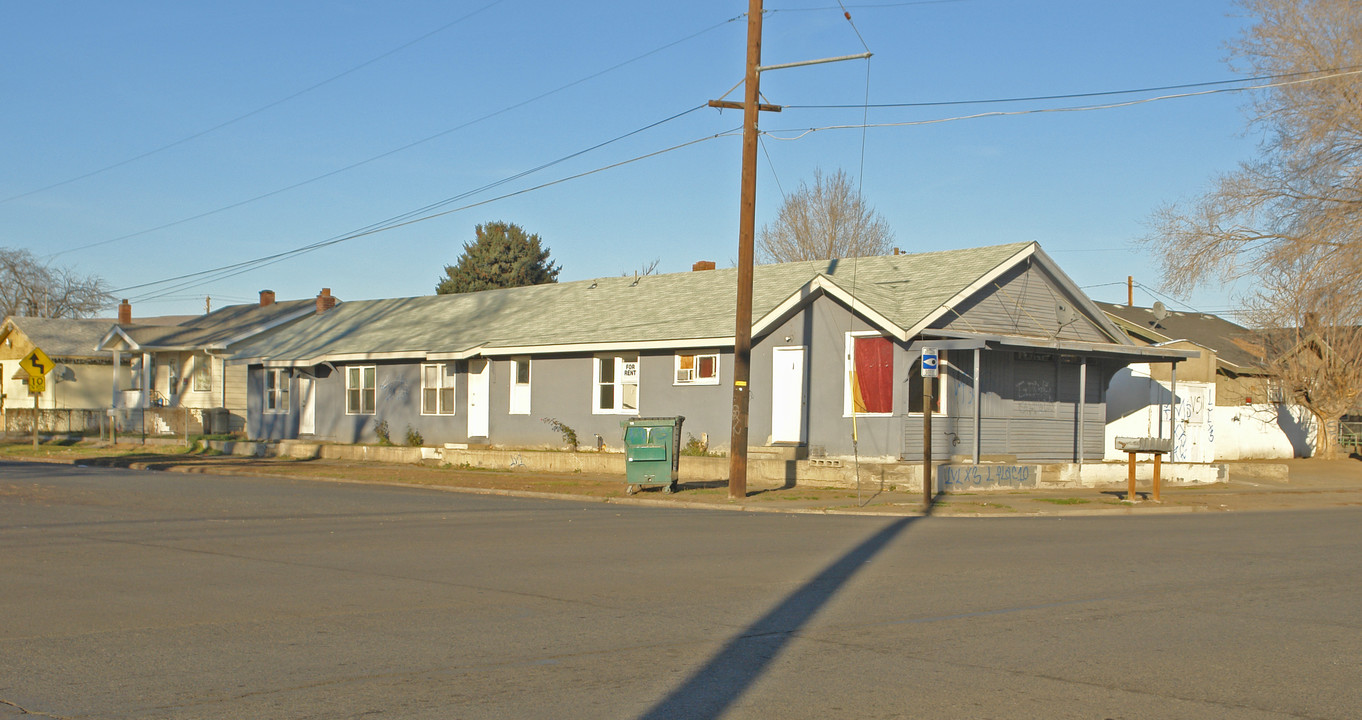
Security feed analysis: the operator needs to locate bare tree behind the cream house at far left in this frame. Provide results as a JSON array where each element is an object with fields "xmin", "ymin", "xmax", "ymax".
[{"xmin": 0, "ymin": 248, "xmax": 113, "ymax": 317}]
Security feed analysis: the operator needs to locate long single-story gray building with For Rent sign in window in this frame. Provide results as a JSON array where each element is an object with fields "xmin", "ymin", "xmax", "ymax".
[{"xmin": 233, "ymin": 242, "xmax": 1196, "ymax": 461}]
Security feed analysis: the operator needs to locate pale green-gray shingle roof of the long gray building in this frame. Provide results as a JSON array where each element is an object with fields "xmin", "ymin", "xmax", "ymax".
[{"xmin": 233, "ymin": 242, "xmax": 1193, "ymax": 366}]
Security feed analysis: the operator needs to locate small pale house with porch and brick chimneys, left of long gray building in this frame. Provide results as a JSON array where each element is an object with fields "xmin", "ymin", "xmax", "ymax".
[{"xmin": 98, "ymin": 289, "xmax": 336, "ymax": 434}]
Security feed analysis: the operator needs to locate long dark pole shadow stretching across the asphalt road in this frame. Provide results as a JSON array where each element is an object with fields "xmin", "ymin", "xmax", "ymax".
[{"xmin": 639, "ymin": 517, "xmax": 919, "ymax": 720}]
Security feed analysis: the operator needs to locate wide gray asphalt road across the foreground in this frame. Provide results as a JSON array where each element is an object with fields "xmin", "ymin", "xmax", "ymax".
[{"xmin": 0, "ymin": 463, "xmax": 1362, "ymax": 719}]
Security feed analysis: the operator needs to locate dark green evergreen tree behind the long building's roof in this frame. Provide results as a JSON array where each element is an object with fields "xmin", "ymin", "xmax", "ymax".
[{"xmin": 434, "ymin": 222, "xmax": 563, "ymax": 295}]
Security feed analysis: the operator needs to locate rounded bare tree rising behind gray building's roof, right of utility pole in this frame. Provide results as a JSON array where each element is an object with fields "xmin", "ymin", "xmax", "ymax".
[{"xmin": 757, "ymin": 170, "xmax": 893, "ymax": 263}]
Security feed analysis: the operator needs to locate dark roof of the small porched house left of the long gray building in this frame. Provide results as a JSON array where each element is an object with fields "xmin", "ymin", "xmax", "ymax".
[{"xmin": 98, "ymin": 299, "xmax": 316, "ymax": 351}]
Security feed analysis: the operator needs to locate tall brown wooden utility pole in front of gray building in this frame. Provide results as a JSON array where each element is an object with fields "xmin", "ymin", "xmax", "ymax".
[{"xmin": 729, "ymin": 0, "xmax": 761, "ymax": 500}]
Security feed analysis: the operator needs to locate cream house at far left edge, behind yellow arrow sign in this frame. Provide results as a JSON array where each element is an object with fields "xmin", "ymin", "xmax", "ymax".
[{"xmin": 0, "ymin": 317, "xmax": 114, "ymax": 433}]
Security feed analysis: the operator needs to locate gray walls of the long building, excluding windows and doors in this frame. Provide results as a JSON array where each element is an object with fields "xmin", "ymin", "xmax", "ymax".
[{"xmin": 248, "ymin": 283, "xmax": 1121, "ymax": 461}]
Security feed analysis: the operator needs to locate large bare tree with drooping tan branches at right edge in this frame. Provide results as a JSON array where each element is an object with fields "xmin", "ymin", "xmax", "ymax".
[{"xmin": 1144, "ymin": 0, "xmax": 1362, "ymax": 456}]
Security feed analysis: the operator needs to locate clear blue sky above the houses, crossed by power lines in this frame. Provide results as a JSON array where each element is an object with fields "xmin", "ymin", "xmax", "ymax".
[{"xmin": 0, "ymin": 0, "xmax": 1258, "ymax": 316}]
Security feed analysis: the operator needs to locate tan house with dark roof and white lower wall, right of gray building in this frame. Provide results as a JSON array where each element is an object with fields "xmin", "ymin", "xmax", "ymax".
[{"xmin": 1096, "ymin": 302, "xmax": 1314, "ymax": 463}]
